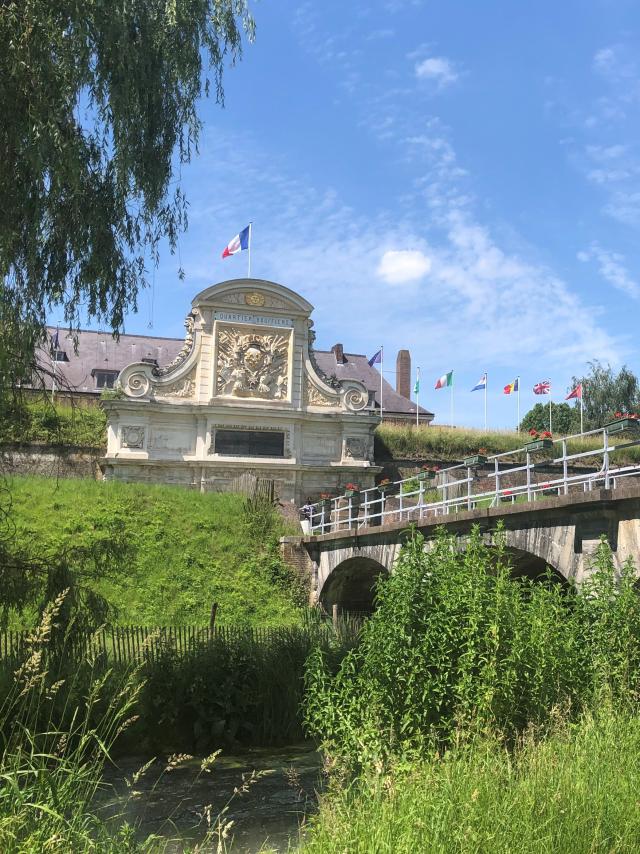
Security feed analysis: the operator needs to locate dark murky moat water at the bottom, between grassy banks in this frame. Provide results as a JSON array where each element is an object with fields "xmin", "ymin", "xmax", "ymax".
[{"xmin": 100, "ymin": 746, "xmax": 323, "ymax": 854}]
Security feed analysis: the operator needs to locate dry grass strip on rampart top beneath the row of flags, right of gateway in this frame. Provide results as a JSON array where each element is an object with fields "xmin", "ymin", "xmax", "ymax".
[{"xmin": 376, "ymin": 424, "xmax": 640, "ymax": 464}]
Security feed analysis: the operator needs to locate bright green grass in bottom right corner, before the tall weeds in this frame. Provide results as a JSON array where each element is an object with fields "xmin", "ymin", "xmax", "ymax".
[{"xmin": 301, "ymin": 708, "xmax": 640, "ymax": 854}]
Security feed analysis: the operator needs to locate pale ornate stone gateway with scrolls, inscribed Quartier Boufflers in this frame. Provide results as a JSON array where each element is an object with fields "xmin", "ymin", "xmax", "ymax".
[{"xmin": 102, "ymin": 279, "xmax": 380, "ymax": 503}]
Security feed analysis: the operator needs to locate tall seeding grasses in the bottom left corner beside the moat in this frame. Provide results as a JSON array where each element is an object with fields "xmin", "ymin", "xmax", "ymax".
[{"xmin": 0, "ymin": 596, "xmax": 142, "ymax": 854}]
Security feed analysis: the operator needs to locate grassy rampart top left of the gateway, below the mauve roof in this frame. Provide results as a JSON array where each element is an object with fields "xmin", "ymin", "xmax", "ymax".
[{"xmin": 0, "ymin": 401, "xmax": 107, "ymax": 451}]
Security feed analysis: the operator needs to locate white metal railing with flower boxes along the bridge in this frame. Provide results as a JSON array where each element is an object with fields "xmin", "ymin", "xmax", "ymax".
[{"xmin": 301, "ymin": 425, "xmax": 640, "ymax": 534}]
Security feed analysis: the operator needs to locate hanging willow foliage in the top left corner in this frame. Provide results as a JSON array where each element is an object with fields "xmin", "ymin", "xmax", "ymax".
[{"xmin": 0, "ymin": 0, "xmax": 254, "ymax": 352}]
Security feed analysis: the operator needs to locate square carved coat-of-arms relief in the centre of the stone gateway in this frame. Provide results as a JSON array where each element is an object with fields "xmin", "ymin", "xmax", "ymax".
[{"xmin": 217, "ymin": 328, "xmax": 289, "ymax": 400}]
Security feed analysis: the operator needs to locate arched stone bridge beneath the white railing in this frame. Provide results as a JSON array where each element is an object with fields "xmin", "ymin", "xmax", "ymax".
[{"xmin": 281, "ymin": 478, "xmax": 640, "ymax": 612}]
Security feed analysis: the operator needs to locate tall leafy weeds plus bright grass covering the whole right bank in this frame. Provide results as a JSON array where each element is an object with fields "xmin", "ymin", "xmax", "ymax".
[{"xmin": 302, "ymin": 531, "xmax": 640, "ymax": 854}]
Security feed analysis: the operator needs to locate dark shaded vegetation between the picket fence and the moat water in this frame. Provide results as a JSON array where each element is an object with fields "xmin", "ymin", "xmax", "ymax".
[{"xmin": 134, "ymin": 624, "xmax": 358, "ymax": 755}]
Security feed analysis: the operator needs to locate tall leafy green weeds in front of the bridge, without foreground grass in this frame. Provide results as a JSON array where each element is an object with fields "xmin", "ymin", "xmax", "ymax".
[{"xmin": 305, "ymin": 530, "xmax": 640, "ymax": 766}]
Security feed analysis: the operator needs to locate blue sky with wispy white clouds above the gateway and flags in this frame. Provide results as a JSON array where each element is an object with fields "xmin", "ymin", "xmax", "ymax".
[{"xmin": 97, "ymin": 0, "xmax": 640, "ymax": 427}]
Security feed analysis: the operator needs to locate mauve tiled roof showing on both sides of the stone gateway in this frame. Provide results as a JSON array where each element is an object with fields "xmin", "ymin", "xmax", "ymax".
[{"xmin": 41, "ymin": 327, "xmax": 433, "ymax": 417}]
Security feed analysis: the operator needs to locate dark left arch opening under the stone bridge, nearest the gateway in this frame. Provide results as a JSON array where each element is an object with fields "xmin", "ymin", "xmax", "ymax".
[{"xmin": 319, "ymin": 555, "xmax": 388, "ymax": 614}]
